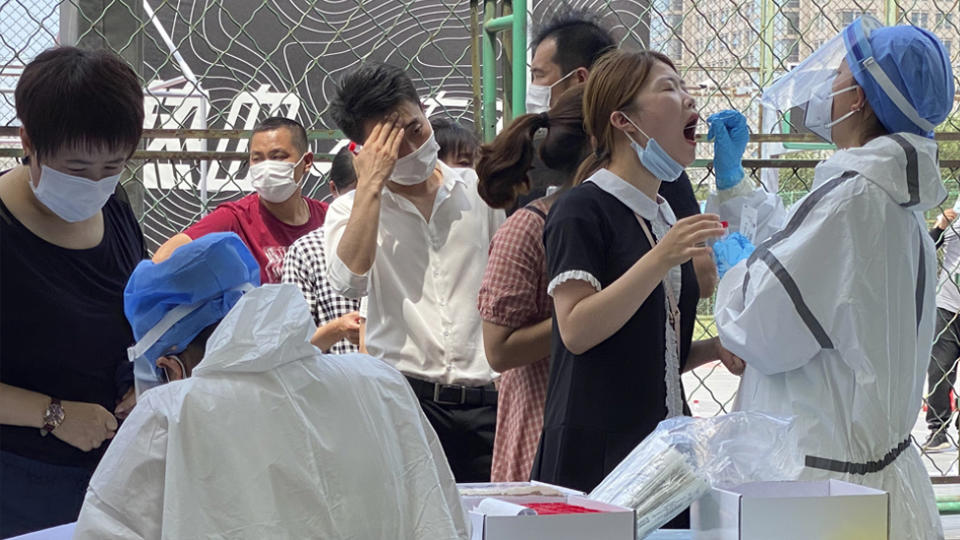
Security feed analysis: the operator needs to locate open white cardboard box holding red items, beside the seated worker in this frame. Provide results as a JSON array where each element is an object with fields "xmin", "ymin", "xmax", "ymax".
[{"xmin": 461, "ymin": 482, "xmax": 636, "ymax": 540}]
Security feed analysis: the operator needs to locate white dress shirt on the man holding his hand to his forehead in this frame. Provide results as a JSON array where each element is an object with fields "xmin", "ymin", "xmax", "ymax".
[{"xmin": 324, "ymin": 162, "xmax": 505, "ymax": 386}]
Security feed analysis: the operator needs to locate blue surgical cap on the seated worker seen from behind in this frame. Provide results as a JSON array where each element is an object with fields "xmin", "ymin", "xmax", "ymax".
[{"xmin": 123, "ymin": 232, "xmax": 260, "ymax": 366}]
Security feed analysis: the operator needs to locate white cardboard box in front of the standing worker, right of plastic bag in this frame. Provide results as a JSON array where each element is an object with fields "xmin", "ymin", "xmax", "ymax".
[{"xmin": 690, "ymin": 480, "xmax": 889, "ymax": 540}]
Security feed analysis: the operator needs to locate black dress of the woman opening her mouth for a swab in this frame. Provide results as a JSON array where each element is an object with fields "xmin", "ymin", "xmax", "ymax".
[{"xmin": 532, "ymin": 181, "xmax": 700, "ymax": 492}]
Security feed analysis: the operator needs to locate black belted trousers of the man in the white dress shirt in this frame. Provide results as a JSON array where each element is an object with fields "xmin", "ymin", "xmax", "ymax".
[{"xmin": 420, "ymin": 398, "xmax": 497, "ymax": 483}]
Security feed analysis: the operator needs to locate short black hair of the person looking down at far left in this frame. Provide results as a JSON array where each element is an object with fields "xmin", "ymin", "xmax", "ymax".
[{"xmin": 14, "ymin": 47, "xmax": 143, "ymax": 159}]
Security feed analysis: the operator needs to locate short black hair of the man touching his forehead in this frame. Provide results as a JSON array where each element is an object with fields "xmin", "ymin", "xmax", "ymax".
[{"xmin": 330, "ymin": 62, "xmax": 420, "ymax": 143}]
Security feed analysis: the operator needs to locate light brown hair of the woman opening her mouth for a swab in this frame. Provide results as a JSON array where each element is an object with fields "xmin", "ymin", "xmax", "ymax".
[{"xmin": 574, "ymin": 50, "xmax": 677, "ymax": 183}]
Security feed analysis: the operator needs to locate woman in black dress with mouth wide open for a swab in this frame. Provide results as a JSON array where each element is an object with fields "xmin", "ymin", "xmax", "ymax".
[{"xmin": 533, "ymin": 51, "xmax": 743, "ymax": 502}]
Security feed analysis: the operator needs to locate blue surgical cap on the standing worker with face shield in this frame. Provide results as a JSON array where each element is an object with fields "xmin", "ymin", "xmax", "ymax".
[{"xmin": 844, "ymin": 24, "xmax": 954, "ymax": 137}]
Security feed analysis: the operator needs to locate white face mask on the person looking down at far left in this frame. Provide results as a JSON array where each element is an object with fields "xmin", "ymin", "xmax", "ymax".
[{"xmin": 29, "ymin": 165, "xmax": 120, "ymax": 223}]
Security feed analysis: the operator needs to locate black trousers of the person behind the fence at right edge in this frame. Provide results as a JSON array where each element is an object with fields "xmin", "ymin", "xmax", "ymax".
[{"xmin": 927, "ymin": 308, "xmax": 960, "ymax": 431}]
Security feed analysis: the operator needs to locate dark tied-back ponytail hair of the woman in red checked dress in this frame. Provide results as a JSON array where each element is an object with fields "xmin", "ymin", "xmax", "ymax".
[{"xmin": 477, "ymin": 85, "xmax": 589, "ymax": 208}]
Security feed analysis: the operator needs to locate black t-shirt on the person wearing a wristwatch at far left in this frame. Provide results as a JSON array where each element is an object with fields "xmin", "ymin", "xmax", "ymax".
[{"xmin": 0, "ymin": 195, "xmax": 145, "ymax": 470}]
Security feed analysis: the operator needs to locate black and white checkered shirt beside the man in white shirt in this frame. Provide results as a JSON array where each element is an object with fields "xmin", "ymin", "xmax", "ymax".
[{"xmin": 283, "ymin": 228, "xmax": 360, "ymax": 354}]
